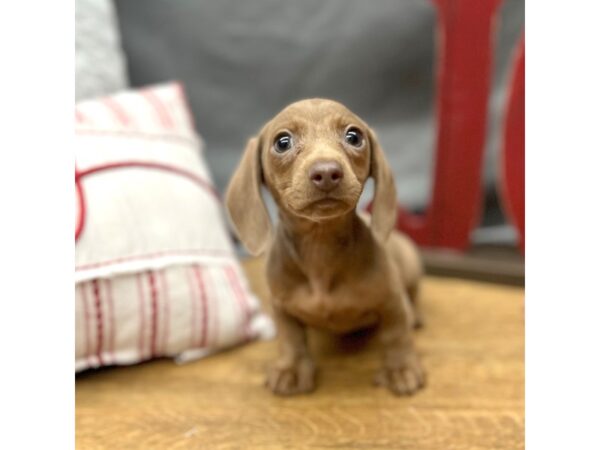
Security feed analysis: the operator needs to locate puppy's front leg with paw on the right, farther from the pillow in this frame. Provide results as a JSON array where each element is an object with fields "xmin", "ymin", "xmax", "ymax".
[{"xmin": 374, "ymin": 292, "xmax": 425, "ymax": 395}]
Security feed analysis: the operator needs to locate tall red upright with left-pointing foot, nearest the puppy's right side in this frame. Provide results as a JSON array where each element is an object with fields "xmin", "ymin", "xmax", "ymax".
[{"xmin": 397, "ymin": 0, "xmax": 500, "ymax": 250}]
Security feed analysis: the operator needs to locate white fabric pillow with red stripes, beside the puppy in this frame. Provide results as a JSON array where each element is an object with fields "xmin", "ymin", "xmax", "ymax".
[{"xmin": 75, "ymin": 84, "xmax": 273, "ymax": 371}]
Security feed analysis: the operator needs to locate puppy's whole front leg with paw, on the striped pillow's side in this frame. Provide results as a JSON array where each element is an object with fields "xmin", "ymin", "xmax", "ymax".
[{"xmin": 266, "ymin": 306, "xmax": 315, "ymax": 395}]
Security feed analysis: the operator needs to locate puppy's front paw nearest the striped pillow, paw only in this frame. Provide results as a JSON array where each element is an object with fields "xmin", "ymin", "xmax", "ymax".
[{"xmin": 265, "ymin": 358, "xmax": 316, "ymax": 395}]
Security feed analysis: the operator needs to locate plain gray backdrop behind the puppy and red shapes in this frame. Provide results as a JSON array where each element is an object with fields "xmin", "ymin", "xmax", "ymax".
[{"xmin": 115, "ymin": 0, "xmax": 524, "ymax": 244}]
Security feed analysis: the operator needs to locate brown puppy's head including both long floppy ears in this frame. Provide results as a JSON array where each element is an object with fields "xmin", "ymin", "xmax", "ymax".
[{"xmin": 226, "ymin": 99, "xmax": 396, "ymax": 254}]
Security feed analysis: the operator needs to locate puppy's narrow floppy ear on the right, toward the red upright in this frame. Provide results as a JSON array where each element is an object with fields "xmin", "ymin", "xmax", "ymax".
[{"xmin": 369, "ymin": 129, "xmax": 398, "ymax": 242}]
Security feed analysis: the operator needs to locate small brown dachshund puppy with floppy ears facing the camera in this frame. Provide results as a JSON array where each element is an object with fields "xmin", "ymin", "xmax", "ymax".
[{"xmin": 226, "ymin": 99, "xmax": 425, "ymax": 395}]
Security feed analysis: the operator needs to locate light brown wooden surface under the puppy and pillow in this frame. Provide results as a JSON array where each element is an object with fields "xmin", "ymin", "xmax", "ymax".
[{"xmin": 76, "ymin": 260, "xmax": 524, "ymax": 450}]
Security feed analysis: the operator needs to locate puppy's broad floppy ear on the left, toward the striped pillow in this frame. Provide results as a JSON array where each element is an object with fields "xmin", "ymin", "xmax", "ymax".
[{"xmin": 225, "ymin": 137, "xmax": 271, "ymax": 255}]
